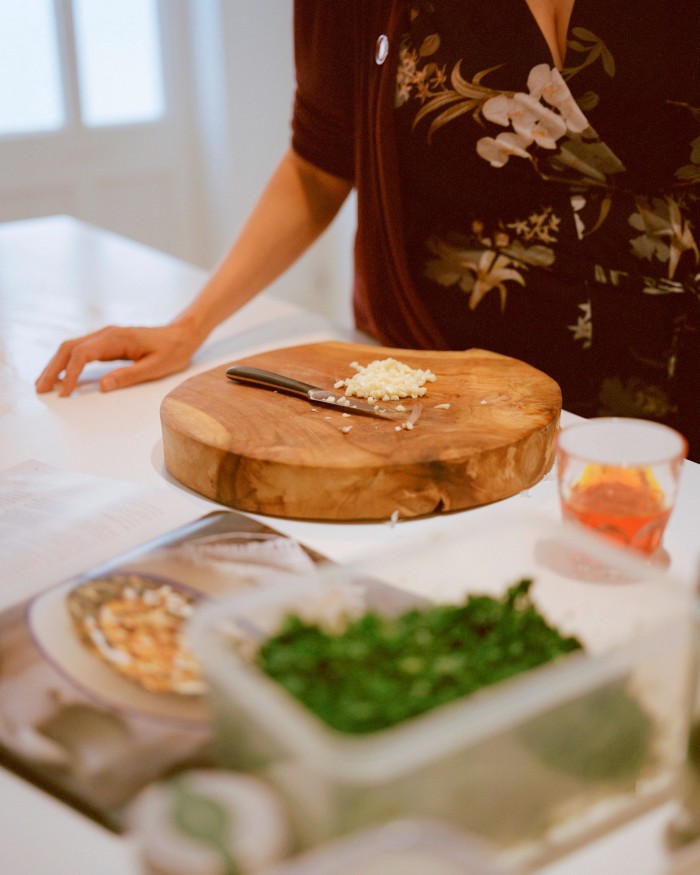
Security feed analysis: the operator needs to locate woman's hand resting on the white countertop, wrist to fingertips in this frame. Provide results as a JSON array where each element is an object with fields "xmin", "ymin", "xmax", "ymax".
[{"xmin": 36, "ymin": 323, "xmax": 200, "ymax": 397}]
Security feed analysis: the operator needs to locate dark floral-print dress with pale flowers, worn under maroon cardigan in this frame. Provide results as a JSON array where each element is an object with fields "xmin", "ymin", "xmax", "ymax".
[{"xmin": 394, "ymin": 0, "xmax": 700, "ymax": 454}]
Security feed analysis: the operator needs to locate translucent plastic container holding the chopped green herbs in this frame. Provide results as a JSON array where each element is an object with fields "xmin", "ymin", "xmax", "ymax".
[{"xmin": 190, "ymin": 515, "xmax": 691, "ymax": 865}]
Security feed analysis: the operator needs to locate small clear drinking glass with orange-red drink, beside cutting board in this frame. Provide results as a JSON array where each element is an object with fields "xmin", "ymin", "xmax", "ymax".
[{"xmin": 556, "ymin": 417, "xmax": 688, "ymax": 556}]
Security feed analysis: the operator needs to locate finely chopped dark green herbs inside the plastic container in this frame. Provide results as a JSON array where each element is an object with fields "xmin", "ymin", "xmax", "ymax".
[{"xmin": 257, "ymin": 580, "xmax": 582, "ymax": 733}]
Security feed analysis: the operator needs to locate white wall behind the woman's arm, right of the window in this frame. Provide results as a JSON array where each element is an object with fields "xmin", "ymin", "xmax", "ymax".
[{"xmin": 188, "ymin": 0, "xmax": 354, "ymax": 326}]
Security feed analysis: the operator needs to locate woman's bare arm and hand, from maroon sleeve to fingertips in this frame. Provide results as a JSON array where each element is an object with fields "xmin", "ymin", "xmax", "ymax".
[{"xmin": 36, "ymin": 149, "xmax": 352, "ymax": 396}]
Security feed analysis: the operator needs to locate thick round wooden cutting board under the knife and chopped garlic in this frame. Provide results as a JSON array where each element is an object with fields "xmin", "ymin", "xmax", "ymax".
[{"xmin": 160, "ymin": 342, "xmax": 561, "ymax": 521}]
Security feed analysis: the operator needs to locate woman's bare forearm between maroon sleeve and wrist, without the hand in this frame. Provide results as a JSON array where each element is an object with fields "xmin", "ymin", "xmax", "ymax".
[{"xmin": 174, "ymin": 150, "xmax": 352, "ymax": 342}]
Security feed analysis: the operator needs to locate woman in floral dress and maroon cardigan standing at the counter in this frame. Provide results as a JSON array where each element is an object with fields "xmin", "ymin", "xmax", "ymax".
[{"xmin": 37, "ymin": 0, "xmax": 700, "ymax": 458}]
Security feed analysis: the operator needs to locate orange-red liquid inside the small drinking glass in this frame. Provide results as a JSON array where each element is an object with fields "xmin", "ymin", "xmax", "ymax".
[{"xmin": 563, "ymin": 466, "xmax": 671, "ymax": 554}]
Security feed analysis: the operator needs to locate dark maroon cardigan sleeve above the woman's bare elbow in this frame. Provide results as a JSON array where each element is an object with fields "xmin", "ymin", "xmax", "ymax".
[{"xmin": 292, "ymin": 0, "xmax": 355, "ymax": 181}]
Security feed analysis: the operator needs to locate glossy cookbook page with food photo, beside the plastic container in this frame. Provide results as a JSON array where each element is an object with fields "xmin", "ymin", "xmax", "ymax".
[{"xmin": 0, "ymin": 511, "xmax": 325, "ymax": 832}]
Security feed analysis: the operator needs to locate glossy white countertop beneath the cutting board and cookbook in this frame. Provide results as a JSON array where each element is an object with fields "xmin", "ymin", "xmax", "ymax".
[{"xmin": 0, "ymin": 217, "xmax": 700, "ymax": 875}]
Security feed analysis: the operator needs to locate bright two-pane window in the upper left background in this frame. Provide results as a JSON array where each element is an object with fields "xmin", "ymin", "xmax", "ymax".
[{"xmin": 0, "ymin": 0, "xmax": 165, "ymax": 135}]
